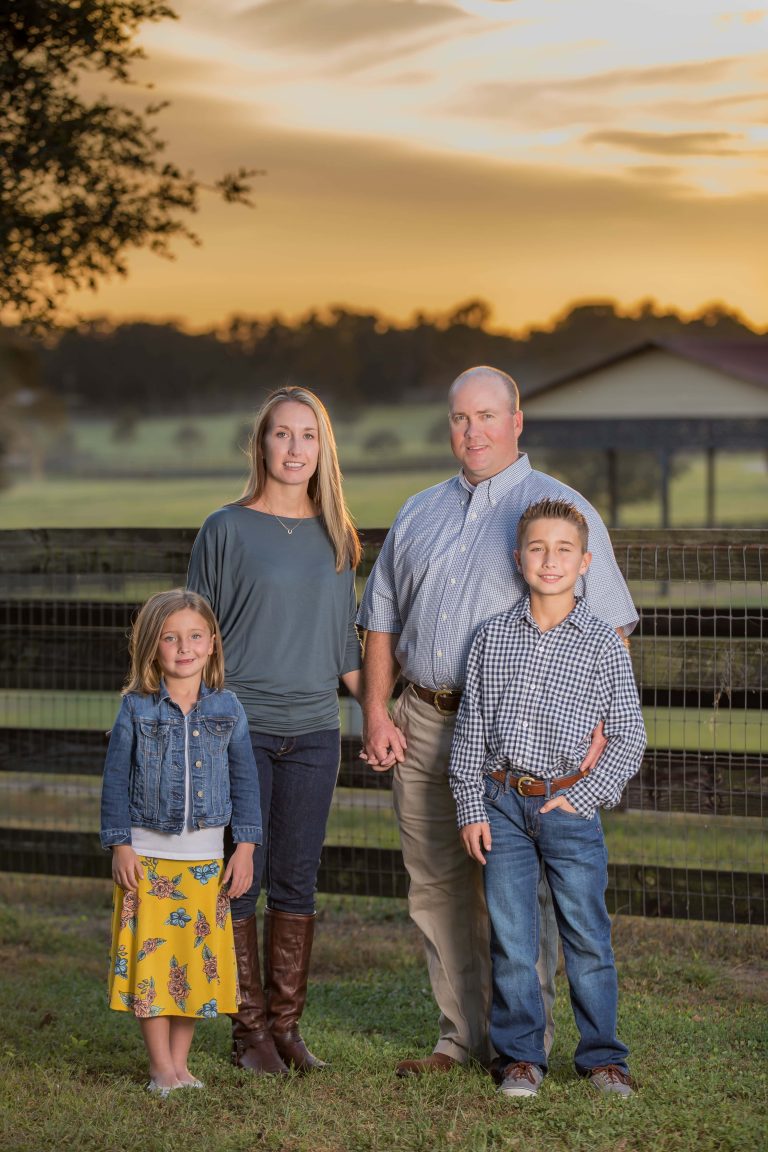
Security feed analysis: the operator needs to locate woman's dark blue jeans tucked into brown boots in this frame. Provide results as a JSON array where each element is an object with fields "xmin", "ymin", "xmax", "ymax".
[{"xmin": 225, "ymin": 728, "xmax": 341, "ymax": 920}]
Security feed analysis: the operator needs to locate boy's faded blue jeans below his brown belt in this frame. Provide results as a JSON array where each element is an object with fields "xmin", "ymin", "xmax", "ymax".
[{"xmin": 485, "ymin": 778, "xmax": 629, "ymax": 1075}]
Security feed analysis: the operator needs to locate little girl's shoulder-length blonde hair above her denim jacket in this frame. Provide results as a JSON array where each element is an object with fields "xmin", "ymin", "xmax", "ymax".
[{"xmin": 123, "ymin": 588, "xmax": 225, "ymax": 696}]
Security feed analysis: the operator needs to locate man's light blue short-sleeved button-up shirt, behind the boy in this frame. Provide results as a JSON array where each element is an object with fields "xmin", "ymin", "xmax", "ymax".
[{"xmin": 357, "ymin": 453, "xmax": 638, "ymax": 690}]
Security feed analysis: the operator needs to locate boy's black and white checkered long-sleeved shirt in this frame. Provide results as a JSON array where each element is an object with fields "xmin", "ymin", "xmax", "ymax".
[{"xmin": 449, "ymin": 597, "xmax": 646, "ymax": 827}]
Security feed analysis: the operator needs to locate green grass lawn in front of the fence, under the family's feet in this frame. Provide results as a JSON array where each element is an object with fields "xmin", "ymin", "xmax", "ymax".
[{"xmin": 0, "ymin": 876, "xmax": 768, "ymax": 1152}]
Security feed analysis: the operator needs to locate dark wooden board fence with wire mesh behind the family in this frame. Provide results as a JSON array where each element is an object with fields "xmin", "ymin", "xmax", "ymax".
[{"xmin": 0, "ymin": 529, "xmax": 768, "ymax": 925}]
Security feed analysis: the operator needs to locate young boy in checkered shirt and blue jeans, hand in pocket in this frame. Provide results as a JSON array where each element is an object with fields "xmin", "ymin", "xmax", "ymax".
[{"xmin": 450, "ymin": 500, "xmax": 645, "ymax": 1097}]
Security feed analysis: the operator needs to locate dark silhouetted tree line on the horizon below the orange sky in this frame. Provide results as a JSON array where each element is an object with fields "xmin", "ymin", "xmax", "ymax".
[{"xmin": 34, "ymin": 301, "xmax": 763, "ymax": 418}]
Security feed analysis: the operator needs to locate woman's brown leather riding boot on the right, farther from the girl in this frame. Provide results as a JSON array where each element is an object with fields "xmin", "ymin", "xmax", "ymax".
[{"xmin": 264, "ymin": 908, "xmax": 326, "ymax": 1073}]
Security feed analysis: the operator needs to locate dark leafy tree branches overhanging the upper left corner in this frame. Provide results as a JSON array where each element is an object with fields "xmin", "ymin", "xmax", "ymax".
[{"xmin": 0, "ymin": 0, "xmax": 257, "ymax": 331}]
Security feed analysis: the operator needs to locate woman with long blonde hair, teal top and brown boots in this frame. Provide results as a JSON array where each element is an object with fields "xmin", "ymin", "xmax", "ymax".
[{"xmin": 188, "ymin": 387, "xmax": 360, "ymax": 1075}]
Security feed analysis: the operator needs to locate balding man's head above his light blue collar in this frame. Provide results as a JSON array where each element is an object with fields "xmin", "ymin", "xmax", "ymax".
[{"xmin": 449, "ymin": 376, "xmax": 523, "ymax": 484}]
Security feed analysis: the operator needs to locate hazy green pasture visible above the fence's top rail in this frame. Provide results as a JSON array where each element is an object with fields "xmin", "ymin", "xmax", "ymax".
[{"xmin": 0, "ymin": 403, "xmax": 768, "ymax": 529}]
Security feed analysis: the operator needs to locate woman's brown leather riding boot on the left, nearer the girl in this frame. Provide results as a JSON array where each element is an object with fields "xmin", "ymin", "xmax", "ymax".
[{"xmin": 230, "ymin": 916, "xmax": 288, "ymax": 1076}]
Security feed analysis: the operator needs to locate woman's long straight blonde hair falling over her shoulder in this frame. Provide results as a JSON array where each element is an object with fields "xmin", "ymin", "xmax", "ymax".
[{"xmin": 235, "ymin": 385, "xmax": 363, "ymax": 571}]
